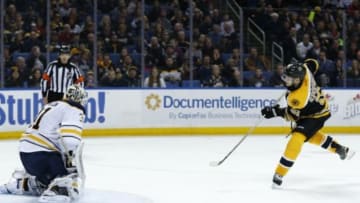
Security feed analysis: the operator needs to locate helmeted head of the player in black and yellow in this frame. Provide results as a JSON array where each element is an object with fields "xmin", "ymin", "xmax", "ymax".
[{"xmin": 281, "ymin": 63, "xmax": 306, "ymax": 90}]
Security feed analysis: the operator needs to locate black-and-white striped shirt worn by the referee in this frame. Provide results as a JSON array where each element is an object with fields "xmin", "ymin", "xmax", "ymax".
[{"xmin": 40, "ymin": 60, "xmax": 84, "ymax": 97}]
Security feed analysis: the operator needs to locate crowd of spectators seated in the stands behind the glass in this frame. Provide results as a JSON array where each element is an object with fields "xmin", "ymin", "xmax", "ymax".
[{"xmin": 3, "ymin": 0, "xmax": 360, "ymax": 88}]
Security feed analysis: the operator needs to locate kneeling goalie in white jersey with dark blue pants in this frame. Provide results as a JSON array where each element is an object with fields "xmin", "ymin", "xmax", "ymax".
[{"xmin": 0, "ymin": 85, "xmax": 87, "ymax": 202}]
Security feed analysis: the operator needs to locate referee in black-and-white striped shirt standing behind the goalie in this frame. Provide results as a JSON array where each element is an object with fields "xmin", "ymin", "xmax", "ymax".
[{"xmin": 40, "ymin": 45, "xmax": 84, "ymax": 104}]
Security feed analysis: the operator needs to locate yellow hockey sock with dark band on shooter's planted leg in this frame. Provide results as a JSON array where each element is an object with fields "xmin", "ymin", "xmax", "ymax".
[{"xmin": 275, "ymin": 132, "xmax": 306, "ymax": 176}]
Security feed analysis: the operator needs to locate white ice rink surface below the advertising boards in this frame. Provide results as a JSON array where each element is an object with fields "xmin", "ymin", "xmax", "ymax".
[{"xmin": 0, "ymin": 134, "xmax": 360, "ymax": 203}]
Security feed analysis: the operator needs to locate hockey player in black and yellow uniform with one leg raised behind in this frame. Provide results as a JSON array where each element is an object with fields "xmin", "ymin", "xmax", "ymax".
[{"xmin": 261, "ymin": 59, "xmax": 354, "ymax": 187}]
